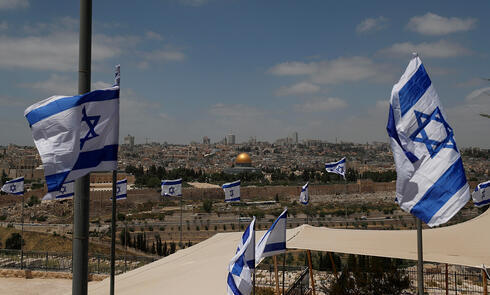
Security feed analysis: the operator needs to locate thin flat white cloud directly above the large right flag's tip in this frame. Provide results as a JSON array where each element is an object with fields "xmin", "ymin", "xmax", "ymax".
[{"xmin": 379, "ymin": 40, "xmax": 471, "ymax": 58}]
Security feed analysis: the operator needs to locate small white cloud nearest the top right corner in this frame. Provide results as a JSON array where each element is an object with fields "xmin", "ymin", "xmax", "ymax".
[{"xmin": 407, "ymin": 12, "xmax": 477, "ymax": 36}]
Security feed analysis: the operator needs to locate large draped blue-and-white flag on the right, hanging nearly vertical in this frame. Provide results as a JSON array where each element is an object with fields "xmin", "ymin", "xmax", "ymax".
[{"xmin": 386, "ymin": 56, "xmax": 470, "ymax": 227}]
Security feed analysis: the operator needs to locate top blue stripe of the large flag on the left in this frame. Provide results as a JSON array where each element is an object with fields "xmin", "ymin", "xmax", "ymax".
[{"xmin": 26, "ymin": 89, "xmax": 119, "ymax": 126}]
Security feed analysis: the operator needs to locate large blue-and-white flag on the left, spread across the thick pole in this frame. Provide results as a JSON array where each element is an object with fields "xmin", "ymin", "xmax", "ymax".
[{"xmin": 24, "ymin": 69, "xmax": 119, "ymax": 192}]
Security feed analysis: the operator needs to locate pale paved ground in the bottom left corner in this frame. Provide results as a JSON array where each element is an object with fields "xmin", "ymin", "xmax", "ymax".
[{"xmin": 0, "ymin": 278, "xmax": 96, "ymax": 295}]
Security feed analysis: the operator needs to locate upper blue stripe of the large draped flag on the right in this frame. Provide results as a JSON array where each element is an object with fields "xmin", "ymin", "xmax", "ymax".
[{"xmin": 398, "ymin": 64, "xmax": 431, "ymax": 116}]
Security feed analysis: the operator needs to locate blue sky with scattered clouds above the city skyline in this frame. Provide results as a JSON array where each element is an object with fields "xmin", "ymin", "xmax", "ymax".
[{"xmin": 0, "ymin": 0, "xmax": 490, "ymax": 148}]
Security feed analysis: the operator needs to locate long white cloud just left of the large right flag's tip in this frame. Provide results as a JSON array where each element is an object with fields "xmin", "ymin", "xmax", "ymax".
[{"xmin": 268, "ymin": 56, "xmax": 393, "ymax": 84}]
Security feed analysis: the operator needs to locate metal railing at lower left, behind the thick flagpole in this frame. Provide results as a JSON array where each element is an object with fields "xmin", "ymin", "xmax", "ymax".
[{"xmin": 0, "ymin": 249, "xmax": 155, "ymax": 274}]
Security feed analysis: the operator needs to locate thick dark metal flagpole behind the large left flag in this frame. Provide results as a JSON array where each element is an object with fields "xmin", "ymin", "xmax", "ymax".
[{"xmin": 72, "ymin": 0, "xmax": 92, "ymax": 295}]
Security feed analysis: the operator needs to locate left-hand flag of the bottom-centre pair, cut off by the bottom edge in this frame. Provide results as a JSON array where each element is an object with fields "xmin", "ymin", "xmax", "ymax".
[{"xmin": 226, "ymin": 217, "xmax": 255, "ymax": 295}]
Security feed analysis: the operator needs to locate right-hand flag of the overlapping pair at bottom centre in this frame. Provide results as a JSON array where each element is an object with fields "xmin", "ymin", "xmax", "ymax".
[{"xmin": 255, "ymin": 208, "xmax": 288, "ymax": 265}]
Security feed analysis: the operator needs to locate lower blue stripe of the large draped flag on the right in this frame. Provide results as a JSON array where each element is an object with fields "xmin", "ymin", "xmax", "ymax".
[{"xmin": 410, "ymin": 158, "xmax": 467, "ymax": 223}]
